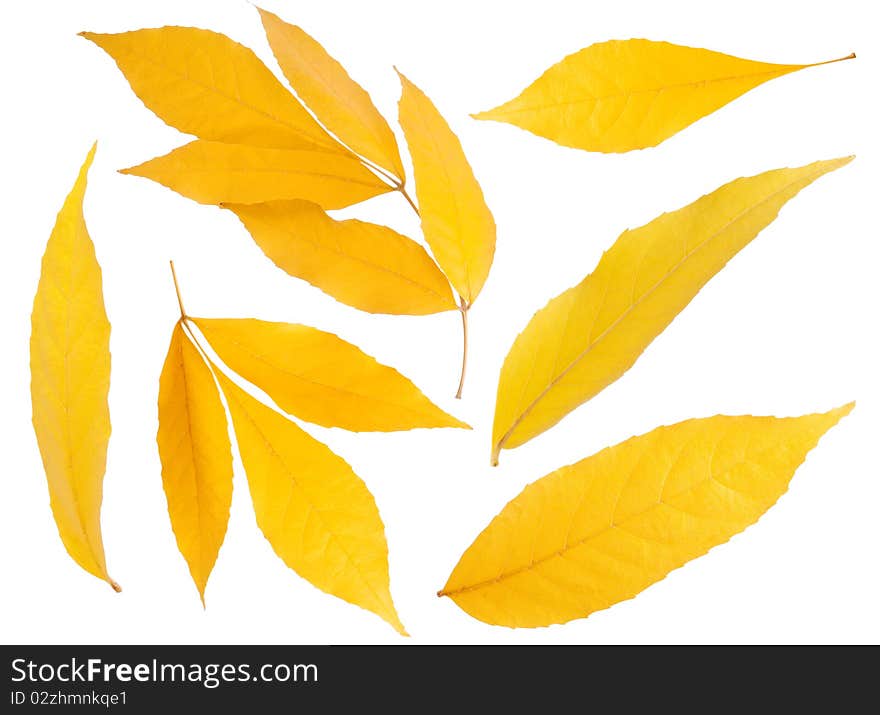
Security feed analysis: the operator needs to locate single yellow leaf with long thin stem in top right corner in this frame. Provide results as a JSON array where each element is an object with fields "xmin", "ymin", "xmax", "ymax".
[{"xmin": 474, "ymin": 40, "xmax": 855, "ymax": 152}]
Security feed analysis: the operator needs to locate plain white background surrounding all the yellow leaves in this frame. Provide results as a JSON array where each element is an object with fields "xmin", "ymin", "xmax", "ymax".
[{"xmin": 0, "ymin": 0, "xmax": 880, "ymax": 643}]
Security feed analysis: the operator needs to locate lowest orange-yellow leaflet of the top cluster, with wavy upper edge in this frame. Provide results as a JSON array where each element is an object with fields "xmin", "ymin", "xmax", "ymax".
[{"xmin": 226, "ymin": 201, "xmax": 457, "ymax": 315}]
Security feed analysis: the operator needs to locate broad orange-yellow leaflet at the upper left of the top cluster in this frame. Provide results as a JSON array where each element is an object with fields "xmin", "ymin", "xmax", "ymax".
[{"xmin": 80, "ymin": 27, "xmax": 344, "ymax": 151}]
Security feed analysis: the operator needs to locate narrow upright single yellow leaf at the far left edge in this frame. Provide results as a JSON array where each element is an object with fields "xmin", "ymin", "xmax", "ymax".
[{"xmin": 30, "ymin": 146, "xmax": 120, "ymax": 591}]
